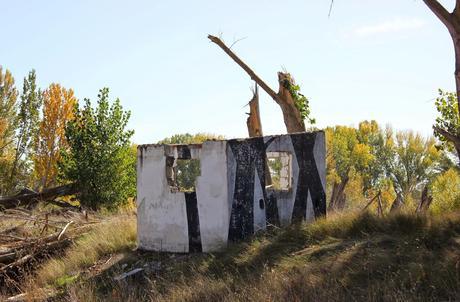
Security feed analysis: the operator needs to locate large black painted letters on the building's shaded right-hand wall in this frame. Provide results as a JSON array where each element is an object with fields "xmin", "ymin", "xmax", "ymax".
[{"xmin": 228, "ymin": 133, "xmax": 326, "ymax": 241}]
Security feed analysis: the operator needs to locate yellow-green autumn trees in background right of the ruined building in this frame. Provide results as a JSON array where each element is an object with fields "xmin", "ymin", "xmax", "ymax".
[{"xmin": 326, "ymin": 121, "xmax": 453, "ymax": 209}]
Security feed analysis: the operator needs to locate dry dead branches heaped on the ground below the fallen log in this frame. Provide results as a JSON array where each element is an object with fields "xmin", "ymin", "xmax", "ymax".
[{"xmin": 0, "ymin": 208, "xmax": 101, "ymax": 301}]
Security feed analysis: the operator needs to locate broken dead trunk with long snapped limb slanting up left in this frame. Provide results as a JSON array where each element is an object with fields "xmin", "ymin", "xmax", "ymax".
[{"xmin": 208, "ymin": 35, "xmax": 305, "ymax": 133}]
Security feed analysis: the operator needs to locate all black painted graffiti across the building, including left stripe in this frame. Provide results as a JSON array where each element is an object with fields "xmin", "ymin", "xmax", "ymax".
[{"xmin": 178, "ymin": 133, "xmax": 326, "ymax": 252}]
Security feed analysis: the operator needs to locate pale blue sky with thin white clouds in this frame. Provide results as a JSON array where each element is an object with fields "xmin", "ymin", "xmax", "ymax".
[{"xmin": 0, "ymin": 0, "xmax": 455, "ymax": 143}]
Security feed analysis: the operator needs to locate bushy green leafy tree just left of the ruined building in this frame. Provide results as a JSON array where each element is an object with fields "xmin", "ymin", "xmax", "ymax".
[{"xmin": 60, "ymin": 88, "xmax": 136, "ymax": 209}]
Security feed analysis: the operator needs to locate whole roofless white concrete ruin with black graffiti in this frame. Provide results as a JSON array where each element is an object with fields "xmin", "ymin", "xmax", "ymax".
[{"xmin": 137, "ymin": 131, "xmax": 326, "ymax": 252}]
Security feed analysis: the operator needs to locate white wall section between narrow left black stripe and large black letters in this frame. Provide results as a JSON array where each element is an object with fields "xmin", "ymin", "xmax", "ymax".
[{"xmin": 195, "ymin": 141, "xmax": 230, "ymax": 252}]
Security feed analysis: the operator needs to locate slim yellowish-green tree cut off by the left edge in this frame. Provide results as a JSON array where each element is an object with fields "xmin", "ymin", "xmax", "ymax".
[{"xmin": 0, "ymin": 66, "xmax": 18, "ymax": 195}]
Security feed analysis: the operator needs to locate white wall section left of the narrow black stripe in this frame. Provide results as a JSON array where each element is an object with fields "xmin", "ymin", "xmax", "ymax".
[{"xmin": 137, "ymin": 145, "xmax": 189, "ymax": 252}]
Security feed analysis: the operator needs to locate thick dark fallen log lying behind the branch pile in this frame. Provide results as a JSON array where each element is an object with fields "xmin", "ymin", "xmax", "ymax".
[{"xmin": 0, "ymin": 184, "xmax": 78, "ymax": 209}]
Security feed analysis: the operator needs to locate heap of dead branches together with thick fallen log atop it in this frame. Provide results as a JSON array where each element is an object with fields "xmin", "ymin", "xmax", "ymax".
[{"xmin": 0, "ymin": 185, "xmax": 102, "ymax": 294}]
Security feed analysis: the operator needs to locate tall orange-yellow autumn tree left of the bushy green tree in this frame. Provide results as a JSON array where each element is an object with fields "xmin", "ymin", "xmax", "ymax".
[{"xmin": 34, "ymin": 83, "xmax": 77, "ymax": 189}]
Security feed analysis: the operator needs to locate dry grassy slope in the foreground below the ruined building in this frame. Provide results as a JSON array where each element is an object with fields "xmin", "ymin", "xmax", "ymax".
[{"xmin": 30, "ymin": 213, "xmax": 460, "ymax": 301}]
